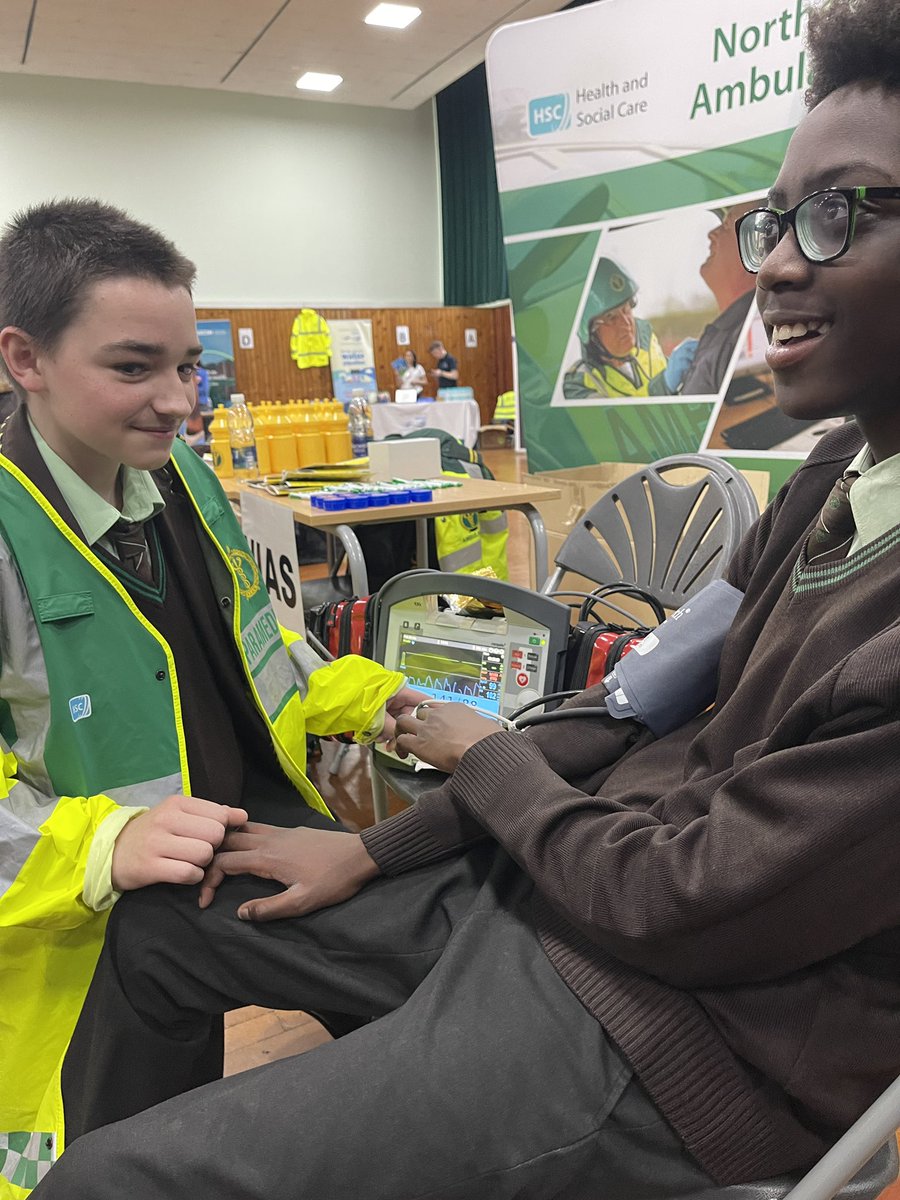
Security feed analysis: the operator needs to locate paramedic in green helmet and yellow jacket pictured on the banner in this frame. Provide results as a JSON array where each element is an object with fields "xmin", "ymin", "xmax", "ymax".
[{"xmin": 563, "ymin": 258, "xmax": 696, "ymax": 400}]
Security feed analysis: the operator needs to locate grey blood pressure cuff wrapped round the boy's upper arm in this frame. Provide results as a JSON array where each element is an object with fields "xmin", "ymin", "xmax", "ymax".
[{"xmin": 604, "ymin": 580, "xmax": 744, "ymax": 738}]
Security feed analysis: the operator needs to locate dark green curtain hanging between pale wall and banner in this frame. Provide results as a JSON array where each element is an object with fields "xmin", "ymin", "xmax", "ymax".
[{"xmin": 436, "ymin": 0, "xmax": 596, "ymax": 305}]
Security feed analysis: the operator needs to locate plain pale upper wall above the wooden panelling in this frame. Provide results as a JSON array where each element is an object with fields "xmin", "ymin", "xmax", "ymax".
[{"xmin": 0, "ymin": 74, "xmax": 443, "ymax": 307}]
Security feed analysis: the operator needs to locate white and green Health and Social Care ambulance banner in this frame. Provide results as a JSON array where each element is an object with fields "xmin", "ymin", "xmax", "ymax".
[{"xmin": 487, "ymin": 0, "xmax": 833, "ymax": 487}]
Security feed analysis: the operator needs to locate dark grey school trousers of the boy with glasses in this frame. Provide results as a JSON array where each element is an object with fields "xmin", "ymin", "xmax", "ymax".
[{"xmin": 40, "ymin": 846, "xmax": 720, "ymax": 1200}]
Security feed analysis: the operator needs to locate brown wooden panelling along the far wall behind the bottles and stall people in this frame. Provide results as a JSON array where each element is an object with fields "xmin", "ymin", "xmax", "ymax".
[{"xmin": 197, "ymin": 305, "xmax": 512, "ymax": 422}]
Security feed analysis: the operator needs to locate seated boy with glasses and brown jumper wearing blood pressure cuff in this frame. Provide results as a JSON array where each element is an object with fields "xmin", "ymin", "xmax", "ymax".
[{"xmin": 30, "ymin": 0, "xmax": 900, "ymax": 1200}]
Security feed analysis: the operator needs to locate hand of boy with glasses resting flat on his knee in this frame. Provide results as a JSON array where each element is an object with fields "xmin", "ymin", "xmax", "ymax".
[{"xmin": 200, "ymin": 821, "xmax": 379, "ymax": 920}]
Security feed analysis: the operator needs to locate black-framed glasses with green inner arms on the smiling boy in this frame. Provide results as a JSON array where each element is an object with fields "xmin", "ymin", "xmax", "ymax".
[{"xmin": 734, "ymin": 187, "xmax": 900, "ymax": 275}]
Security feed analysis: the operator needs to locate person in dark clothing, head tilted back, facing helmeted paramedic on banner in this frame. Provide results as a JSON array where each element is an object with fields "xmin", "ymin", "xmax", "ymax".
[{"xmin": 680, "ymin": 200, "xmax": 760, "ymax": 396}]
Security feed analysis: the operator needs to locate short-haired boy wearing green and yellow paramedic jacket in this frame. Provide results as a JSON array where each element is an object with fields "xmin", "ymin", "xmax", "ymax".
[{"xmin": 0, "ymin": 200, "xmax": 420, "ymax": 1200}]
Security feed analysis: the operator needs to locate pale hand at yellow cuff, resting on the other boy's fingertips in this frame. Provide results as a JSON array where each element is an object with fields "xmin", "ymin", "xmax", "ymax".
[{"xmin": 113, "ymin": 796, "xmax": 247, "ymax": 892}]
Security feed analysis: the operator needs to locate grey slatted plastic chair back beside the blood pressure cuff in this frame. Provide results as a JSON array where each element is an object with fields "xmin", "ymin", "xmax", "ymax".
[{"xmin": 540, "ymin": 455, "xmax": 758, "ymax": 608}]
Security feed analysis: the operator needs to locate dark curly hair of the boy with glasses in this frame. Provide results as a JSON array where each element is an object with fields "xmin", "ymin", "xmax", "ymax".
[{"xmin": 806, "ymin": 0, "xmax": 900, "ymax": 108}]
